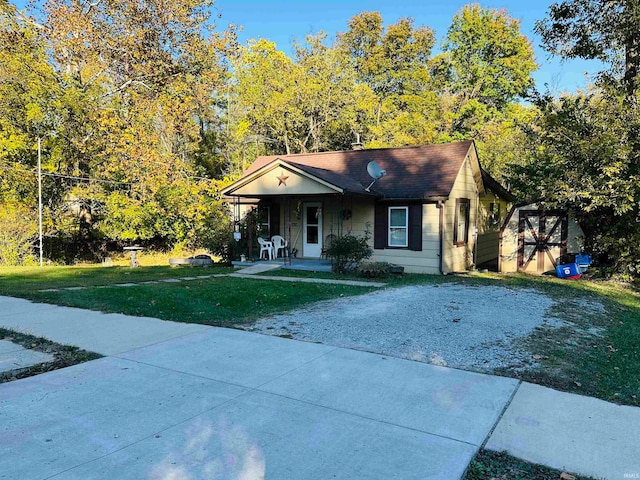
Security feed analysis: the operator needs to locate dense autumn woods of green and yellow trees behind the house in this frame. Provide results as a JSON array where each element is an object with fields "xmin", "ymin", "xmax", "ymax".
[{"xmin": 0, "ymin": 0, "xmax": 640, "ymax": 277}]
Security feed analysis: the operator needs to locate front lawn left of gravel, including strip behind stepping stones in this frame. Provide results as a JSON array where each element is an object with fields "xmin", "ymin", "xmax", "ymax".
[{"xmin": 0, "ymin": 267, "xmax": 373, "ymax": 327}]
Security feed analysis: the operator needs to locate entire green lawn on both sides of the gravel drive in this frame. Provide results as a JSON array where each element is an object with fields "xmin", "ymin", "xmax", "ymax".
[{"xmin": 0, "ymin": 266, "xmax": 640, "ymax": 406}]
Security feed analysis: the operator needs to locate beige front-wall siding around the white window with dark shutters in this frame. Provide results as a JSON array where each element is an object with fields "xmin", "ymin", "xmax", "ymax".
[{"xmin": 371, "ymin": 203, "xmax": 440, "ymax": 274}]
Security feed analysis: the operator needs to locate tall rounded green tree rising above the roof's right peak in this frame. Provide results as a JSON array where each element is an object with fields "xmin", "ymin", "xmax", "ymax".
[{"xmin": 430, "ymin": 4, "xmax": 537, "ymax": 178}]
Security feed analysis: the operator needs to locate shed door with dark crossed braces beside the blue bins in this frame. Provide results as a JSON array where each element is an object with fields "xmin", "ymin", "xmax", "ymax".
[{"xmin": 518, "ymin": 210, "xmax": 568, "ymax": 273}]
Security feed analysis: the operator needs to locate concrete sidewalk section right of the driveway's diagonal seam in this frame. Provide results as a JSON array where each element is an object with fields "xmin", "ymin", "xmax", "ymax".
[{"xmin": 486, "ymin": 383, "xmax": 640, "ymax": 480}]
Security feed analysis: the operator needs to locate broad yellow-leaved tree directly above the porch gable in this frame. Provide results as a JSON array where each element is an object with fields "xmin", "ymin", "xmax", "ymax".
[{"xmin": 233, "ymin": 33, "xmax": 367, "ymax": 154}]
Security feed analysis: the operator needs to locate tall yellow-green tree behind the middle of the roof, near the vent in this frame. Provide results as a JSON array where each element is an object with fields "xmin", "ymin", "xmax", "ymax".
[{"xmin": 337, "ymin": 12, "xmax": 437, "ymax": 147}]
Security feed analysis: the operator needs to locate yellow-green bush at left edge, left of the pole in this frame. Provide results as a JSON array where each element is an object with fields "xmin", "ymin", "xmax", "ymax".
[{"xmin": 0, "ymin": 203, "xmax": 38, "ymax": 265}]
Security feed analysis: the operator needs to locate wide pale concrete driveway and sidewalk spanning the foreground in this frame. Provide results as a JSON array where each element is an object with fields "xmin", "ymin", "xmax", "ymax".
[{"xmin": 0, "ymin": 297, "xmax": 640, "ymax": 480}]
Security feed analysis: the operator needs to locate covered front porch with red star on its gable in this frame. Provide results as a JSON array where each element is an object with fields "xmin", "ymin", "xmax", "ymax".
[{"xmin": 223, "ymin": 159, "xmax": 375, "ymax": 260}]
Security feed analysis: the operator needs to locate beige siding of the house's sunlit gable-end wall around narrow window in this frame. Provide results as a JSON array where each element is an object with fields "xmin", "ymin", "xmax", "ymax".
[{"xmin": 442, "ymin": 157, "xmax": 478, "ymax": 273}]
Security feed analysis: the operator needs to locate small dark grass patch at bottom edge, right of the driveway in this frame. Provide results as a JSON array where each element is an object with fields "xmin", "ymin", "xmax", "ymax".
[{"xmin": 464, "ymin": 450, "xmax": 593, "ymax": 480}]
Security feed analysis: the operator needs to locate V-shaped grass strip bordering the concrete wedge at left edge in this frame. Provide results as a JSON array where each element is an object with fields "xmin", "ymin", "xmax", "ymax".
[{"xmin": 0, "ymin": 328, "xmax": 102, "ymax": 383}]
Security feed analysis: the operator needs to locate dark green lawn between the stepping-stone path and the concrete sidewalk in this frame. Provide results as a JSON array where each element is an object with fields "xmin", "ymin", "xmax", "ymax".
[{"xmin": 0, "ymin": 272, "xmax": 373, "ymax": 327}]
